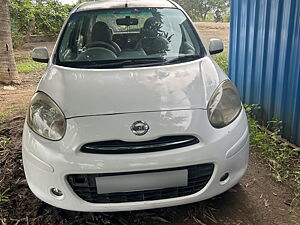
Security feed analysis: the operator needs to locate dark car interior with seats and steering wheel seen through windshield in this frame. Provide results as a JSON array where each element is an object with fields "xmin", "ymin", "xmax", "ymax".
[{"xmin": 60, "ymin": 8, "xmax": 196, "ymax": 62}]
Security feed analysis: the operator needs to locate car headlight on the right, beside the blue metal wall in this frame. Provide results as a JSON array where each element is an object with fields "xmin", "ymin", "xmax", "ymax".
[{"xmin": 207, "ymin": 80, "xmax": 242, "ymax": 128}]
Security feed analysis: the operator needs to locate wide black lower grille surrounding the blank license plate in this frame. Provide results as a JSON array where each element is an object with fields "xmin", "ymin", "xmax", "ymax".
[{"xmin": 67, "ymin": 164, "xmax": 214, "ymax": 203}]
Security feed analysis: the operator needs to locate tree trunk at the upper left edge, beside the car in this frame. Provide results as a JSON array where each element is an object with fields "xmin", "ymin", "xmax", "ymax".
[{"xmin": 0, "ymin": 0, "xmax": 20, "ymax": 84}]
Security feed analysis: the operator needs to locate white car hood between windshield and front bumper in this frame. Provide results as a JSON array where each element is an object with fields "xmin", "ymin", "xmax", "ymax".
[{"xmin": 37, "ymin": 57, "xmax": 226, "ymax": 118}]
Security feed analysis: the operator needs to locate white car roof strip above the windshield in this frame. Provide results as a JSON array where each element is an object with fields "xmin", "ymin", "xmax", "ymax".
[{"xmin": 76, "ymin": 0, "xmax": 176, "ymax": 12}]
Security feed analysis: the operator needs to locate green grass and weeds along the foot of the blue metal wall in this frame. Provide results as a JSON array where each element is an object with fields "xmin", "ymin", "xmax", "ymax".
[{"xmin": 245, "ymin": 105, "xmax": 300, "ymax": 200}]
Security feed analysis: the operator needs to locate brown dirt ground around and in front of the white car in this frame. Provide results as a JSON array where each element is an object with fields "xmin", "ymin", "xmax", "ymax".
[{"xmin": 0, "ymin": 23, "xmax": 300, "ymax": 225}]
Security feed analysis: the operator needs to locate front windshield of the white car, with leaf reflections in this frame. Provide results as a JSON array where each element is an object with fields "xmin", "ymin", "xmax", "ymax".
[{"xmin": 56, "ymin": 8, "xmax": 205, "ymax": 68}]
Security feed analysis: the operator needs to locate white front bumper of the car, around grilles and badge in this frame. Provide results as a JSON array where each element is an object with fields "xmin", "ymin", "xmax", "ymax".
[{"xmin": 22, "ymin": 110, "xmax": 249, "ymax": 212}]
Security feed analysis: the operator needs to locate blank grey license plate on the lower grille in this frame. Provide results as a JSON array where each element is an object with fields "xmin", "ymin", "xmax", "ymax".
[{"xmin": 96, "ymin": 170, "xmax": 188, "ymax": 194}]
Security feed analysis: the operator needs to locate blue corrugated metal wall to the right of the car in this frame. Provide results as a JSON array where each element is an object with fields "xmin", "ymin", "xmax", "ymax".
[{"xmin": 229, "ymin": 0, "xmax": 300, "ymax": 146}]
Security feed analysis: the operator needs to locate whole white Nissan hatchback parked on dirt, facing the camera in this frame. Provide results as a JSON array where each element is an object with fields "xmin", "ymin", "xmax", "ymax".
[{"xmin": 22, "ymin": 0, "xmax": 249, "ymax": 212}]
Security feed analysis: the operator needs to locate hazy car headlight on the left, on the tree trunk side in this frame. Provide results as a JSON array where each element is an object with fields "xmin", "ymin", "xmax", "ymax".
[{"xmin": 27, "ymin": 92, "xmax": 66, "ymax": 141}]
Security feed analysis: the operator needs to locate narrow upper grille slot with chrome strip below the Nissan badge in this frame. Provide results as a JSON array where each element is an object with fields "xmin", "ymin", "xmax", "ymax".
[{"xmin": 81, "ymin": 135, "xmax": 199, "ymax": 154}]
